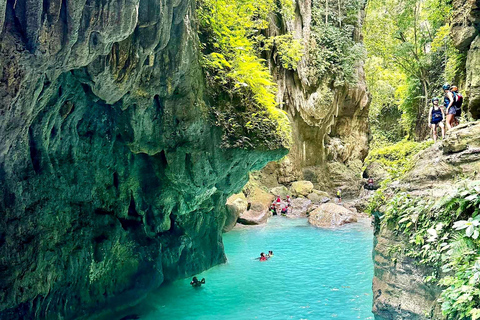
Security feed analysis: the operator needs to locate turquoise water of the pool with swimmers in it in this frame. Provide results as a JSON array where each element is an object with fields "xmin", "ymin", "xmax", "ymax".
[{"xmin": 131, "ymin": 217, "xmax": 373, "ymax": 320}]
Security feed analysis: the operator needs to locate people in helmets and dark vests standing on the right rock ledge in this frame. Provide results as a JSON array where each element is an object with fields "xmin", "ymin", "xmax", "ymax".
[{"xmin": 428, "ymin": 83, "xmax": 463, "ymax": 142}]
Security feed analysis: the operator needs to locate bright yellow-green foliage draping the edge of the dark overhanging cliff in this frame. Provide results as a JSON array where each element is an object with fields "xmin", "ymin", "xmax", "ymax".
[{"xmin": 197, "ymin": 0, "xmax": 291, "ymax": 149}]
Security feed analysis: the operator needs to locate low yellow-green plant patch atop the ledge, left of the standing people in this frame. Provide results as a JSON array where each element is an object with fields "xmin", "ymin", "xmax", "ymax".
[{"xmin": 365, "ymin": 139, "xmax": 433, "ymax": 179}]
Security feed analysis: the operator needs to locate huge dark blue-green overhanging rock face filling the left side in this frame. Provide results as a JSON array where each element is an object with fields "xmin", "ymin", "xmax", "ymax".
[{"xmin": 0, "ymin": 0, "xmax": 286, "ymax": 320}]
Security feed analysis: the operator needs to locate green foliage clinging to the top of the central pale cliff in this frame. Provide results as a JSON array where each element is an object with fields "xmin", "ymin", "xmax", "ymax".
[{"xmin": 309, "ymin": 0, "xmax": 365, "ymax": 86}]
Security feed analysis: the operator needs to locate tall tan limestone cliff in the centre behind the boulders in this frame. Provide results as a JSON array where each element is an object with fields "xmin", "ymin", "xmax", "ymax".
[{"xmin": 260, "ymin": 1, "xmax": 370, "ymax": 195}]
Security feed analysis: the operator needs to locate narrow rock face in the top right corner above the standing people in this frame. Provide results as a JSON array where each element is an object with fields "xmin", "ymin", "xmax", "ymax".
[{"xmin": 451, "ymin": 0, "xmax": 480, "ymax": 119}]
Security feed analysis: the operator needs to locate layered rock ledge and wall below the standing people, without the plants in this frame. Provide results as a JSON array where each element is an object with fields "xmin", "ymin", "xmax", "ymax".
[{"xmin": 373, "ymin": 121, "xmax": 480, "ymax": 320}]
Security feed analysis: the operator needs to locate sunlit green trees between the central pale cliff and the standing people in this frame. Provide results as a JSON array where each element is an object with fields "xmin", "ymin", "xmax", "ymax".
[{"xmin": 364, "ymin": 0, "xmax": 461, "ymax": 144}]
